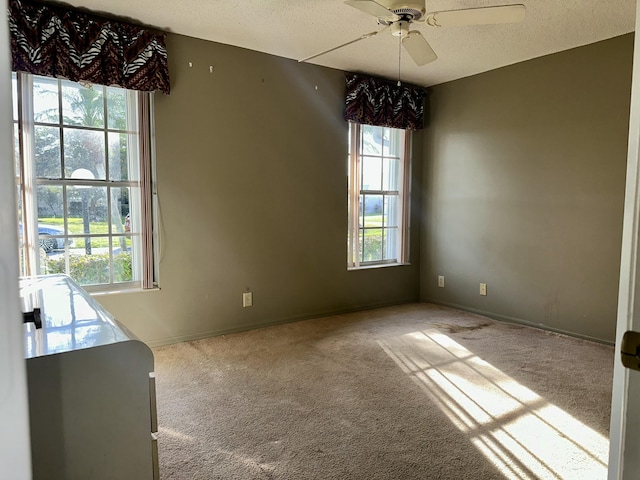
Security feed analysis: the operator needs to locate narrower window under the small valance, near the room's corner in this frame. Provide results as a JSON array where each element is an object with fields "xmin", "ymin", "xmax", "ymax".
[{"xmin": 348, "ymin": 122, "xmax": 410, "ymax": 268}]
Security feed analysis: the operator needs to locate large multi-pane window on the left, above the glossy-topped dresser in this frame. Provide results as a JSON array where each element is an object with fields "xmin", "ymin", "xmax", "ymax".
[{"xmin": 12, "ymin": 73, "xmax": 154, "ymax": 291}]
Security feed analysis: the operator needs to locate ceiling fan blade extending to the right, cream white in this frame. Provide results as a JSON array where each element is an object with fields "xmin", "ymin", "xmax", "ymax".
[{"xmin": 424, "ymin": 5, "xmax": 526, "ymax": 27}]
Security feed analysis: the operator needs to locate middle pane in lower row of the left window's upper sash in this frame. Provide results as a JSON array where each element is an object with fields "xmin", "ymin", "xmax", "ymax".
[{"xmin": 64, "ymin": 128, "xmax": 106, "ymax": 180}]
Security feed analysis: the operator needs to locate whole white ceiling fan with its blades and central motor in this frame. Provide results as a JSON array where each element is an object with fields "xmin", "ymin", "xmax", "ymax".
[{"xmin": 298, "ymin": 0, "xmax": 525, "ymax": 66}]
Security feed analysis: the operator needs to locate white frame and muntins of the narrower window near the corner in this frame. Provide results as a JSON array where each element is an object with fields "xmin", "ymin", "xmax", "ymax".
[{"xmin": 347, "ymin": 122, "xmax": 411, "ymax": 270}]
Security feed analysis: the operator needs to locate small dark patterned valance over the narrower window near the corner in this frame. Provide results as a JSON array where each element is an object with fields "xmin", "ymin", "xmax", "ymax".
[{"xmin": 344, "ymin": 73, "xmax": 427, "ymax": 130}]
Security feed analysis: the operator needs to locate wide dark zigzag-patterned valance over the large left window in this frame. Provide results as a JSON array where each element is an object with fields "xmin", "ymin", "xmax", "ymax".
[{"xmin": 9, "ymin": 0, "xmax": 169, "ymax": 94}]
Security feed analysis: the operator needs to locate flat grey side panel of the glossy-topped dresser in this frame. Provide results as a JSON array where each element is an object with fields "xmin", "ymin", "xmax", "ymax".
[{"xmin": 27, "ymin": 341, "xmax": 154, "ymax": 480}]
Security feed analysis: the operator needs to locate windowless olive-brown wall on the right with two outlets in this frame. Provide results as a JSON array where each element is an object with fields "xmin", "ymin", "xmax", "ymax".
[{"xmin": 420, "ymin": 35, "xmax": 633, "ymax": 341}]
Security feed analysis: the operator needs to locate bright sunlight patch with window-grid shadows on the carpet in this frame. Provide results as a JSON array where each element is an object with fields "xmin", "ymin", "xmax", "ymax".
[{"xmin": 378, "ymin": 330, "xmax": 609, "ymax": 480}]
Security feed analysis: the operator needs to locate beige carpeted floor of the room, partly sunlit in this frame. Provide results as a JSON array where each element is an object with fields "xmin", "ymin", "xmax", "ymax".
[{"xmin": 154, "ymin": 304, "xmax": 614, "ymax": 480}]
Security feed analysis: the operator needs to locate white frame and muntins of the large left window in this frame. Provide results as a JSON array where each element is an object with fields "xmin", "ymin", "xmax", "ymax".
[{"xmin": 13, "ymin": 73, "xmax": 158, "ymax": 293}]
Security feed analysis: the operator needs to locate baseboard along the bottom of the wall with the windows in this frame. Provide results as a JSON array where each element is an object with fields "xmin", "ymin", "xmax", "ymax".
[{"xmin": 145, "ymin": 297, "xmax": 420, "ymax": 348}]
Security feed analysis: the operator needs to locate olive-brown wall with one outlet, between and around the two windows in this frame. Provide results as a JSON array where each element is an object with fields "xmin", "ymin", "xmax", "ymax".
[{"xmin": 98, "ymin": 35, "xmax": 423, "ymax": 344}]
